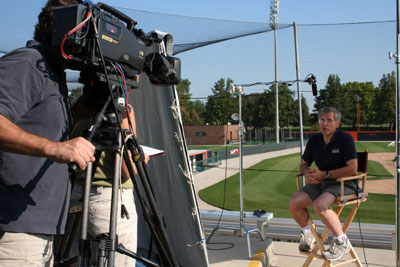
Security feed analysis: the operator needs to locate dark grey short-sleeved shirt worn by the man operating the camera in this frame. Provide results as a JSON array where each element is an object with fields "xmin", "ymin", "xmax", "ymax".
[{"xmin": 0, "ymin": 41, "xmax": 71, "ymax": 234}]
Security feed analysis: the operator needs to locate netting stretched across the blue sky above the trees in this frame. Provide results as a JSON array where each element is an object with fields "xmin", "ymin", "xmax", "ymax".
[{"xmin": 109, "ymin": 8, "xmax": 395, "ymax": 107}]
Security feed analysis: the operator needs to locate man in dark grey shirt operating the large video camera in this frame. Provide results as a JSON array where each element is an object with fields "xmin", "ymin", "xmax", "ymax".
[{"xmin": 0, "ymin": 0, "xmax": 95, "ymax": 266}]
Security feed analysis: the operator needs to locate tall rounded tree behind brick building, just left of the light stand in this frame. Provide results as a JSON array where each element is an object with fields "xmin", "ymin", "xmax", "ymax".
[{"xmin": 204, "ymin": 78, "xmax": 238, "ymax": 125}]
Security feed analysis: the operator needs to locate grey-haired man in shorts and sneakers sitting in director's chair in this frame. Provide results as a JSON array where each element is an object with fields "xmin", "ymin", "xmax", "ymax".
[{"xmin": 289, "ymin": 107, "xmax": 357, "ymax": 261}]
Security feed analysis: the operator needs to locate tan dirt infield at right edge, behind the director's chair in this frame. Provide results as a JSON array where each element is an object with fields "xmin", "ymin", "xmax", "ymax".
[{"xmin": 366, "ymin": 153, "xmax": 396, "ymax": 195}]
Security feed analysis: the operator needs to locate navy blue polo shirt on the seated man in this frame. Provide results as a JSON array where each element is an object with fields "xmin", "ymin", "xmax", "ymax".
[{"xmin": 303, "ymin": 129, "xmax": 357, "ymax": 184}]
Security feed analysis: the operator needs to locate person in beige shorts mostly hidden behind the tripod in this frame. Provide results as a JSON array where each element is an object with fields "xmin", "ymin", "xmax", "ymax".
[{"xmin": 70, "ymin": 83, "xmax": 149, "ymax": 267}]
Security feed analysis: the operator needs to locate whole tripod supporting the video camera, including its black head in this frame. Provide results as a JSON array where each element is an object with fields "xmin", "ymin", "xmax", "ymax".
[{"xmin": 53, "ymin": 91, "xmax": 178, "ymax": 267}]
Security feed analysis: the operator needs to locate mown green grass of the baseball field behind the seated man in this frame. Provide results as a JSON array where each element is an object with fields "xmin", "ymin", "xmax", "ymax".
[{"xmin": 199, "ymin": 143, "xmax": 395, "ymax": 224}]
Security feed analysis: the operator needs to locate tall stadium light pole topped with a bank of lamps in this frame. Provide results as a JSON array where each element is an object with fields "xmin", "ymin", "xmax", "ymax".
[{"xmin": 269, "ymin": 0, "xmax": 279, "ymax": 144}]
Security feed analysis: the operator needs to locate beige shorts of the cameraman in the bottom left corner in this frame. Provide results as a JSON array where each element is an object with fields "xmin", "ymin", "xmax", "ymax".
[{"xmin": 0, "ymin": 232, "xmax": 54, "ymax": 267}]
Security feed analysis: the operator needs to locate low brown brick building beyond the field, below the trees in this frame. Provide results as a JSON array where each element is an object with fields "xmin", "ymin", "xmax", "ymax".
[{"xmin": 184, "ymin": 124, "xmax": 239, "ymax": 145}]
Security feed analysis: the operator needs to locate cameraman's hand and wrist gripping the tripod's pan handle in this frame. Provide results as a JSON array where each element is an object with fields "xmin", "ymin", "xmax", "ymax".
[{"xmin": 48, "ymin": 137, "xmax": 95, "ymax": 170}]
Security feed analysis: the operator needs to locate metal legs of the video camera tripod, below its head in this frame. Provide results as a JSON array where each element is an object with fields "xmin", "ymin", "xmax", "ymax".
[{"xmin": 80, "ymin": 103, "xmax": 177, "ymax": 267}]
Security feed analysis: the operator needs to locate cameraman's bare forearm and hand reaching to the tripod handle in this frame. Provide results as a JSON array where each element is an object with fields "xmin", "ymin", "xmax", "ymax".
[{"xmin": 0, "ymin": 114, "xmax": 94, "ymax": 170}]
